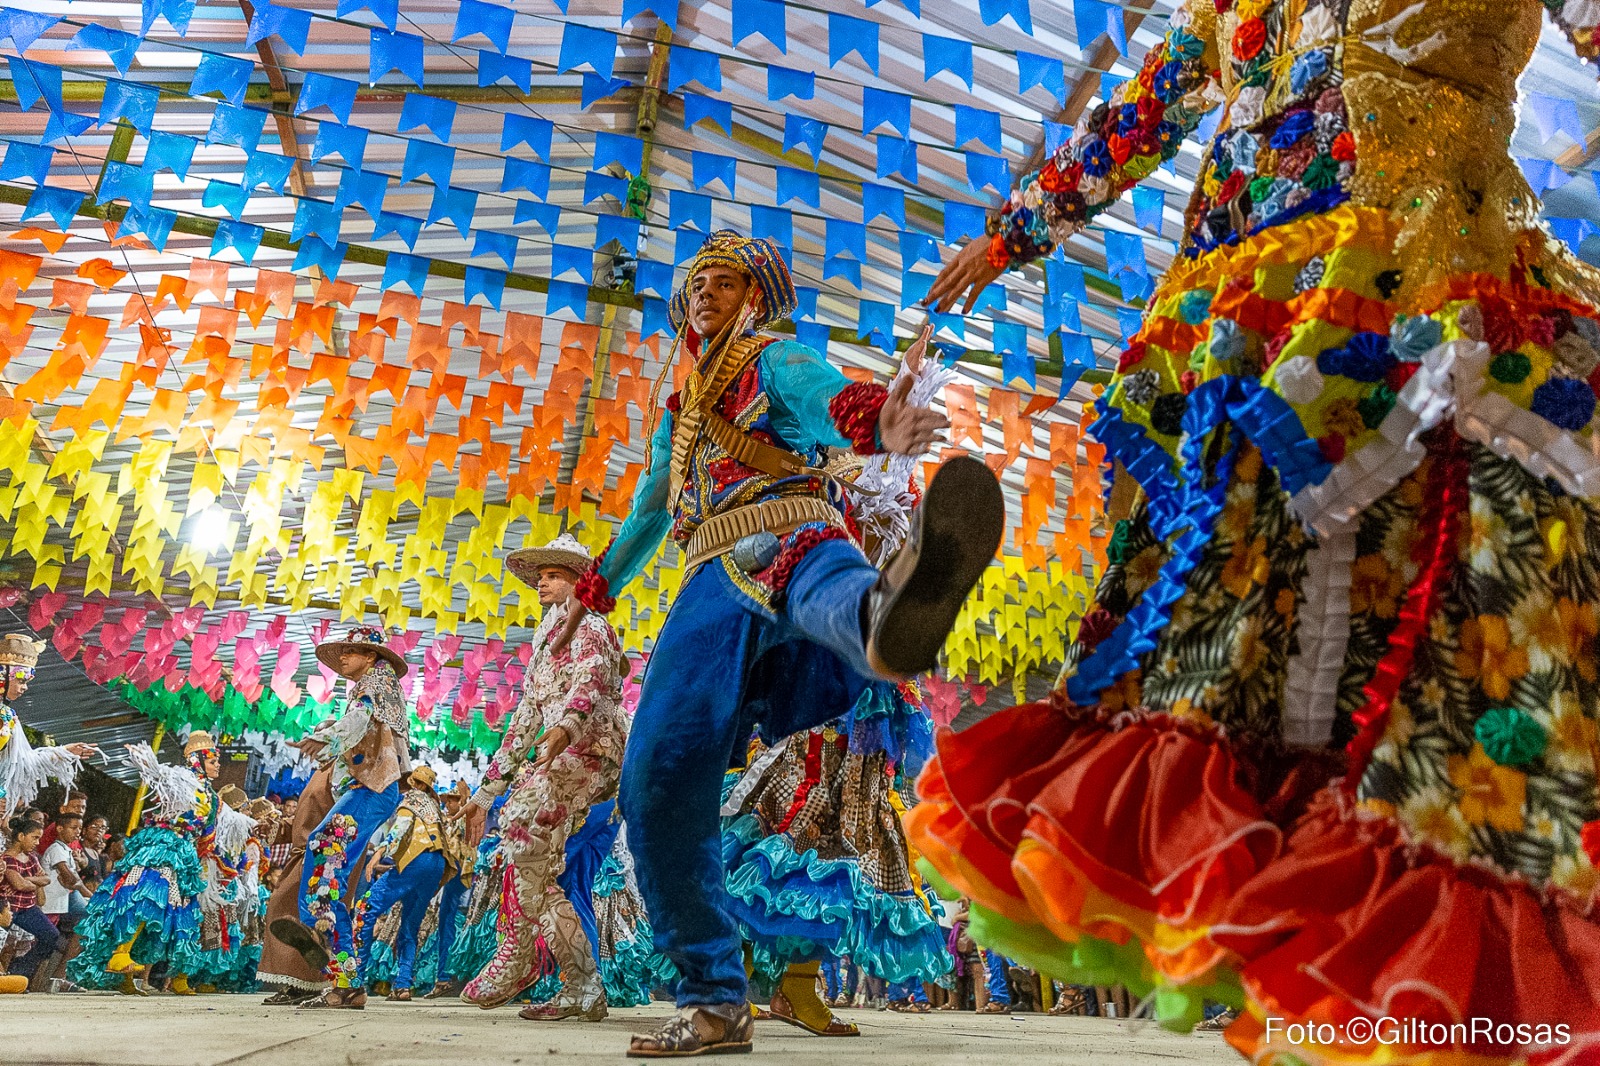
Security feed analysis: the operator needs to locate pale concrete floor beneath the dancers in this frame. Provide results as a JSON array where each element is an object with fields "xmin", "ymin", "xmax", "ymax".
[{"xmin": 0, "ymin": 996, "xmax": 1240, "ymax": 1066}]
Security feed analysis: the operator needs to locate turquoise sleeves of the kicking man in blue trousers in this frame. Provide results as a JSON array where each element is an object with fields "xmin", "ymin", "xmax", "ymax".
[{"xmin": 600, "ymin": 341, "xmax": 851, "ymax": 592}]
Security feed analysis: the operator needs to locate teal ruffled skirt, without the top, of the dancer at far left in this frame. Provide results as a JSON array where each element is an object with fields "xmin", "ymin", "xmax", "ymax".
[{"xmin": 67, "ymin": 826, "xmax": 205, "ymax": 988}]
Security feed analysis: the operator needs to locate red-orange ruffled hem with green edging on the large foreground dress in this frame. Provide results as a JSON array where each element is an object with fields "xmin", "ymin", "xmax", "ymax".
[{"xmin": 906, "ymin": 704, "xmax": 1600, "ymax": 1066}]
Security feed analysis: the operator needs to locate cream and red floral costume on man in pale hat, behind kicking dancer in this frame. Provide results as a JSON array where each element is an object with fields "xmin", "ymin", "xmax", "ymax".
[{"xmin": 462, "ymin": 607, "xmax": 627, "ymax": 1008}]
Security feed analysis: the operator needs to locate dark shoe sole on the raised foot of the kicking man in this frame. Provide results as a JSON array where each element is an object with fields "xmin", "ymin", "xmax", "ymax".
[{"xmin": 867, "ymin": 458, "xmax": 1005, "ymax": 679}]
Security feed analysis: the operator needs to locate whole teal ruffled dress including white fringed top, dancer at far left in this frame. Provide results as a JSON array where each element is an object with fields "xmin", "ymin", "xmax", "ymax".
[{"xmin": 67, "ymin": 744, "xmax": 222, "ymax": 989}]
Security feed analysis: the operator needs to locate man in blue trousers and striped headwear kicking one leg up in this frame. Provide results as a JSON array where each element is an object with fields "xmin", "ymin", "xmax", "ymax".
[{"xmin": 550, "ymin": 230, "xmax": 1005, "ymax": 1058}]
